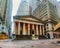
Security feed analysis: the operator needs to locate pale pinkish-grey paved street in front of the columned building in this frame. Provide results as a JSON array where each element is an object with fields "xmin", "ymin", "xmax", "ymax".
[{"xmin": 0, "ymin": 39, "xmax": 60, "ymax": 48}]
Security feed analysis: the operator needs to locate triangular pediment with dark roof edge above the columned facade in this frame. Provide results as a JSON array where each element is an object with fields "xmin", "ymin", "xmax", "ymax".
[{"xmin": 14, "ymin": 16, "xmax": 42, "ymax": 23}]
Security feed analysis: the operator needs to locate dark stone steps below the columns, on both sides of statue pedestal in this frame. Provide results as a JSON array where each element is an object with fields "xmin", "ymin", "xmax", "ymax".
[{"xmin": 15, "ymin": 35, "xmax": 47, "ymax": 40}]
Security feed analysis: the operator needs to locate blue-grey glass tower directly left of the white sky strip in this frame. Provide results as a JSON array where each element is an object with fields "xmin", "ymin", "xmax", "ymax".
[{"xmin": 6, "ymin": 0, "xmax": 13, "ymax": 35}]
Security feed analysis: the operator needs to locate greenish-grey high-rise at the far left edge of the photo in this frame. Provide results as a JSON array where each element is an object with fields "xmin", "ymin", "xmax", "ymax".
[{"xmin": 0, "ymin": 0, "xmax": 7, "ymax": 24}]
